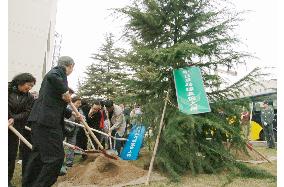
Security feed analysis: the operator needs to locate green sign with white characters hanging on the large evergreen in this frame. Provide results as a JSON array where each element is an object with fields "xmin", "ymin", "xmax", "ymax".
[{"xmin": 173, "ymin": 67, "xmax": 211, "ymax": 114}]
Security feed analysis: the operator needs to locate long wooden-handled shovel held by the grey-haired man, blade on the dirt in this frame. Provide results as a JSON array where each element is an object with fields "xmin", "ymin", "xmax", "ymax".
[{"xmin": 69, "ymin": 102, "xmax": 119, "ymax": 160}]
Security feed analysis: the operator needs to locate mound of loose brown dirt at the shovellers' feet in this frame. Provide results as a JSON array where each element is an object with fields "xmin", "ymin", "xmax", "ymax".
[{"xmin": 58, "ymin": 155, "xmax": 147, "ymax": 187}]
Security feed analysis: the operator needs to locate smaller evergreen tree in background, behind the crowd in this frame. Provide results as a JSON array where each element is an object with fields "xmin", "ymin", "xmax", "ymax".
[{"xmin": 79, "ymin": 33, "xmax": 130, "ymax": 100}]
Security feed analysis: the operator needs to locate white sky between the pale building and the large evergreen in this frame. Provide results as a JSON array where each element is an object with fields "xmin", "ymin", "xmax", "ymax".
[{"xmin": 55, "ymin": 0, "xmax": 128, "ymax": 90}]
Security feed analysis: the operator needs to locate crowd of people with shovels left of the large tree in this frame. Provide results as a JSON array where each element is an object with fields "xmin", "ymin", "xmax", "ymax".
[{"xmin": 8, "ymin": 56, "xmax": 144, "ymax": 187}]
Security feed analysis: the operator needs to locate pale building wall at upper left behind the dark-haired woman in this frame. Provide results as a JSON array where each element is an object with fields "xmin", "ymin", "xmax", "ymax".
[{"xmin": 8, "ymin": 0, "xmax": 57, "ymax": 91}]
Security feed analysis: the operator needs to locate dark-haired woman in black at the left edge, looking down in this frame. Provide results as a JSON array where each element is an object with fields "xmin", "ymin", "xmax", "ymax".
[{"xmin": 8, "ymin": 73, "xmax": 36, "ymax": 186}]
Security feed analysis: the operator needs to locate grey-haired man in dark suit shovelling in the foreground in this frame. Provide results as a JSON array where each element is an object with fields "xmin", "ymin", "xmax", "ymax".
[{"xmin": 22, "ymin": 56, "xmax": 82, "ymax": 187}]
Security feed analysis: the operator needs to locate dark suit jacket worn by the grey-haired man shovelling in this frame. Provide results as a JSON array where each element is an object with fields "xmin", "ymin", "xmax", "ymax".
[{"xmin": 28, "ymin": 66, "xmax": 72, "ymax": 129}]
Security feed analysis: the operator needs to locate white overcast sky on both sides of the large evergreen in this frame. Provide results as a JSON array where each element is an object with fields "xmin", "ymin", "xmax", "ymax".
[{"xmin": 55, "ymin": 0, "xmax": 277, "ymax": 90}]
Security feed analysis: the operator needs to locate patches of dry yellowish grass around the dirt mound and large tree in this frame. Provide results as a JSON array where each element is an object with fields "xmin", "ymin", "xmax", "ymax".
[{"xmin": 12, "ymin": 147, "xmax": 277, "ymax": 187}]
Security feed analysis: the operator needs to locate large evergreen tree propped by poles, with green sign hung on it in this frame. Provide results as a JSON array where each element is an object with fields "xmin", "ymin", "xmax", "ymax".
[{"xmin": 117, "ymin": 0, "xmax": 274, "ymax": 182}]
